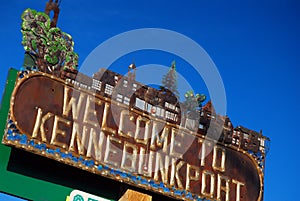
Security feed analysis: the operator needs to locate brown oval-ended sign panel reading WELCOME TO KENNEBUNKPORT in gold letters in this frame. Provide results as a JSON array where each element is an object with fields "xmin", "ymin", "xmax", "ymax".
[{"xmin": 3, "ymin": 72, "xmax": 263, "ymax": 201}]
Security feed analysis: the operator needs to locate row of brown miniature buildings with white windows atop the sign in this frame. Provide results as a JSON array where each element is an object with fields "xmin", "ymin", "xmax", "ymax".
[{"xmin": 66, "ymin": 69, "xmax": 268, "ymax": 157}]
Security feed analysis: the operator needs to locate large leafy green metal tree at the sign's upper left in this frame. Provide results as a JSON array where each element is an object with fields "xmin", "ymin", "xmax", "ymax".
[{"xmin": 21, "ymin": 9, "xmax": 78, "ymax": 72}]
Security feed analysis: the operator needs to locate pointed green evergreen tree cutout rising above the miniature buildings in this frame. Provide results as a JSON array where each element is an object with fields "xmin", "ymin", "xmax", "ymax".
[{"xmin": 160, "ymin": 61, "xmax": 179, "ymax": 97}]
